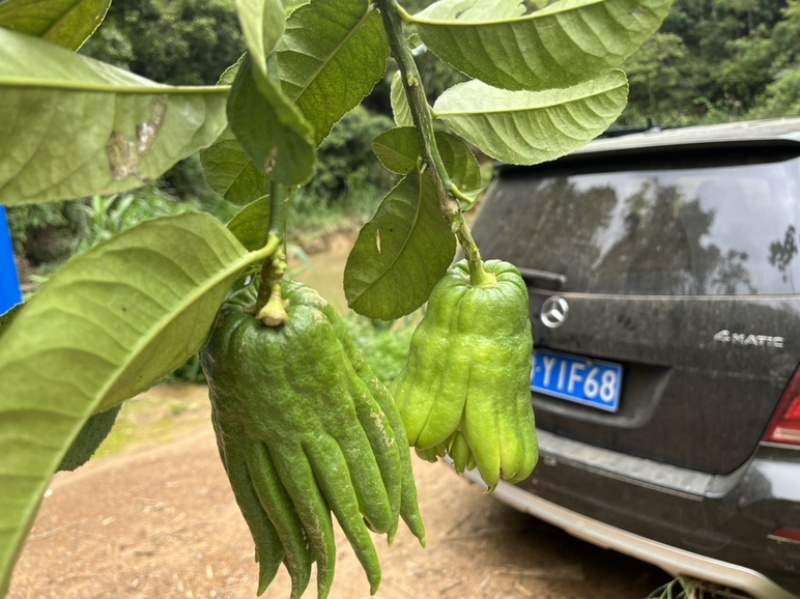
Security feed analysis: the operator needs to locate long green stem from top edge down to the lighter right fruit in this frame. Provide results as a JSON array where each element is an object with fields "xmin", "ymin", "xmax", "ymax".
[{"xmin": 377, "ymin": 0, "xmax": 494, "ymax": 287}]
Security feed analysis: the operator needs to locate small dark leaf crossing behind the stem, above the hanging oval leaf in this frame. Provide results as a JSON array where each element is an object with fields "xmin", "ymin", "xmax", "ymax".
[{"xmin": 372, "ymin": 127, "xmax": 482, "ymax": 192}]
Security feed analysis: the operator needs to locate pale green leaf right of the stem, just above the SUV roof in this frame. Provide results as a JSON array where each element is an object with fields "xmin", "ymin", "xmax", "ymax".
[{"xmin": 433, "ymin": 70, "xmax": 628, "ymax": 164}]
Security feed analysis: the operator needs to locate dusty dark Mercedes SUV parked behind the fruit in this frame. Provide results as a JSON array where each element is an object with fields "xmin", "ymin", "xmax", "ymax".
[{"xmin": 474, "ymin": 119, "xmax": 800, "ymax": 599}]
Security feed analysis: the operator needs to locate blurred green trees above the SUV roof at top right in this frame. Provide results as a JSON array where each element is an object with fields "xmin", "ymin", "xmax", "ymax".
[{"xmin": 621, "ymin": 0, "xmax": 800, "ymax": 125}]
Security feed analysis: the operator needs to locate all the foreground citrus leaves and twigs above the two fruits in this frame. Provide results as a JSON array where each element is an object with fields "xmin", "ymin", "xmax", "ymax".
[{"xmin": 0, "ymin": 0, "xmax": 671, "ymax": 595}]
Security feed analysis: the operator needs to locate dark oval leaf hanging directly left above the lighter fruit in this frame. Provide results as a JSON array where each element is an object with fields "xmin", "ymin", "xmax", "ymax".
[{"xmin": 344, "ymin": 171, "xmax": 456, "ymax": 320}]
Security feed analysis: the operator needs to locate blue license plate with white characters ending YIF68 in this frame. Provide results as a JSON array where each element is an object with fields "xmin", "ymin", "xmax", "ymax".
[{"xmin": 531, "ymin": 349, "xmax": 622, "ymax": 412}]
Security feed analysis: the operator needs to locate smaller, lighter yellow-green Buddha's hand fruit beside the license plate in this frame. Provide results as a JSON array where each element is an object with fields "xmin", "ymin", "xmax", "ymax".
[{"xmin": 393, "ymin": 260, "xmax": 539, "ymax": 489}]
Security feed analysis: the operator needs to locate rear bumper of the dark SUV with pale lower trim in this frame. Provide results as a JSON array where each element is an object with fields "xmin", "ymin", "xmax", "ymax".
[{"xmin": 460, "ymin": 431, "xmax": 800, "ymax": 599}]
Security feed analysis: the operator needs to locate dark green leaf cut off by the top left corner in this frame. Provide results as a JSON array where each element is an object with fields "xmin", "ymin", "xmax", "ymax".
[{"xmin": 0, "ymin": 0, "xmax": 111, "ymax": 50}]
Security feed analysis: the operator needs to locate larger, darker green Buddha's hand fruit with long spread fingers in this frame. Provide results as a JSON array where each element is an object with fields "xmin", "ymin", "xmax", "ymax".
[{"xmin": 202, "ymin": 281, "xmax": 424, "ymax": 598}]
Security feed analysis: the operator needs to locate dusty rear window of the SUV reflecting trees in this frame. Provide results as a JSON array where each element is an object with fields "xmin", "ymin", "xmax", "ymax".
[{"xmin": 487, "ymin": 149, "xmax": 800, "ymax": 295}]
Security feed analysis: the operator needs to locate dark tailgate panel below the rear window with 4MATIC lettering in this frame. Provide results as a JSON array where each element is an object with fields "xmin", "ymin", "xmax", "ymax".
[{"xmin": 530, "ymin": 290, "xmax": 800, "ymax": 474}]
